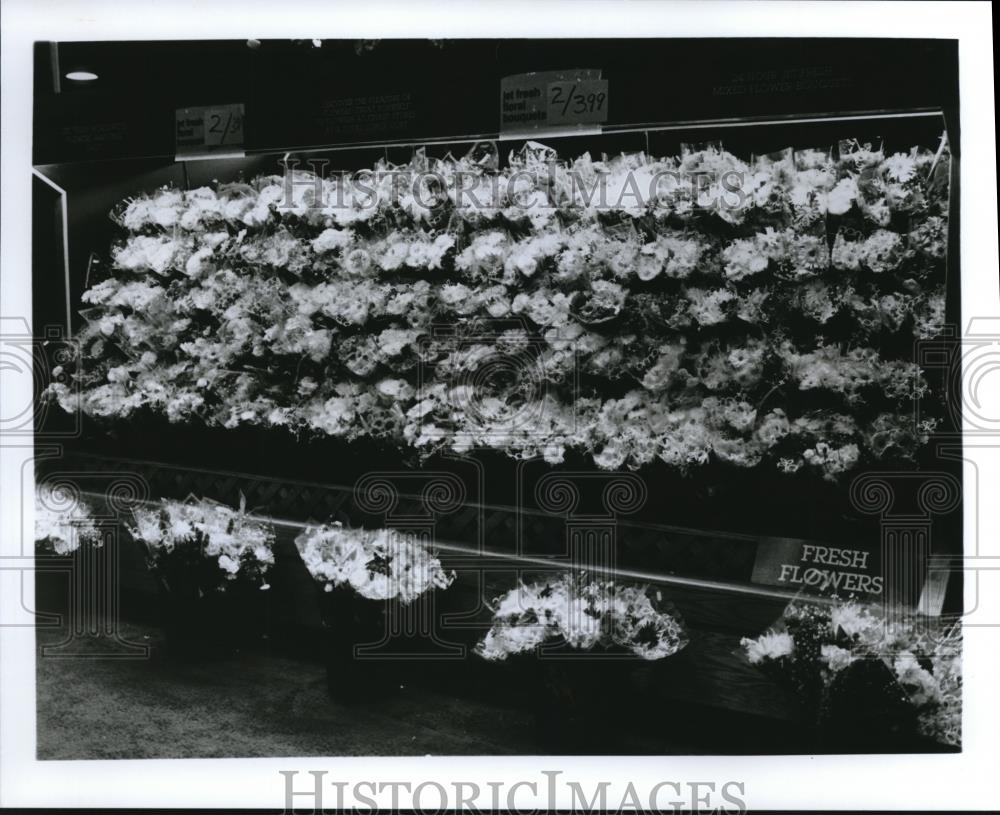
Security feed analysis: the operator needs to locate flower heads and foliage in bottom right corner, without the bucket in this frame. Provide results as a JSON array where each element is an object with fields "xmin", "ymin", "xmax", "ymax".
[{"xmin": 741, "ymin": 601, "xmax": 962, "ymax": 746}]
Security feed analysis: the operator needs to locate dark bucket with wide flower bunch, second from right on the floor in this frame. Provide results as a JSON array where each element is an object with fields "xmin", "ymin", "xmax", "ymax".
[{"xmin": 476, "ymin": 573, "xmax": 688, "ymax": 750}]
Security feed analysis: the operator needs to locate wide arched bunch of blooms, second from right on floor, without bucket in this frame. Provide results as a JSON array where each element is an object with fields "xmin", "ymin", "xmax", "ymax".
[{"xmin": 476, "ymin": 574, "xmax": 687, "ymax": 660}]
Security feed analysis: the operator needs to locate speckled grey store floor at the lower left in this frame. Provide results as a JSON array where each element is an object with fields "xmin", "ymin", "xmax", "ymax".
[{"xmin": 37, "ymin": 624, "xmax": 712, "ymax": 760}]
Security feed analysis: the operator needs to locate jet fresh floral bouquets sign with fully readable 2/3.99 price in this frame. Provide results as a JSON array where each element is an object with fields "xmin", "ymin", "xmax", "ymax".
[{"xmin": 500, "ymin": 69, "xmax": 609, "ymax": 136}]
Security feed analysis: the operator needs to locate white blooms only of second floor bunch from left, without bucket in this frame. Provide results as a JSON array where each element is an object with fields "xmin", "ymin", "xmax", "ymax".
[{"xmin": 129, "ymin": 496, "xmax": 274, "ymax": 591}]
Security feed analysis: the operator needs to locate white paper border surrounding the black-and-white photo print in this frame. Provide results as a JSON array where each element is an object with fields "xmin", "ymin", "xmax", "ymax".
[{"xmin": 0, "ymin": 0, "xmax": 1000, "ymax": 810}]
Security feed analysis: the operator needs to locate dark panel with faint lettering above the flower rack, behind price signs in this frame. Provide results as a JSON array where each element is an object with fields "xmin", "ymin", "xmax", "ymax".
[{"xmin": 34, "ymin": 39, "xmax": 958, "ymax": 164}]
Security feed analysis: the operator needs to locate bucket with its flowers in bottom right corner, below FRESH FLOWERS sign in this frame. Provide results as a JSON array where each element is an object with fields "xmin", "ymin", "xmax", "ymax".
[{"xmin": 742, "ymin": 599, "xmax": 962, "ymax": 752}]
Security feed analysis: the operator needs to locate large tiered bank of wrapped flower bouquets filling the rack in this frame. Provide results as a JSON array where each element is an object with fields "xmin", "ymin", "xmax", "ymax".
[{"xmin": 49, "ymin": 143, "xmax": 948, "ymax": 479}]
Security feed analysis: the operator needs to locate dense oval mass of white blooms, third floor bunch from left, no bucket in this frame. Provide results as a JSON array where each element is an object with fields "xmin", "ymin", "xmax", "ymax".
[{"xmin": 295, "ymin": 523, "xmax": 455, "ymax": 603}]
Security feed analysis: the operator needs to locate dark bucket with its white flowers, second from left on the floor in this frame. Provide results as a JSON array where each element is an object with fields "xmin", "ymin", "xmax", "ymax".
[{"xmin": 129, "ymin": 495, "xmax": 274, "ymax": 657}]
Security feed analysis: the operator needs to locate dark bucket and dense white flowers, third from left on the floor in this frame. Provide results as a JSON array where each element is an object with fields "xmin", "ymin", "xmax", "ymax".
[{"xmin": 295, "ymin": 522, "xmax": 455, "ymax": 701}]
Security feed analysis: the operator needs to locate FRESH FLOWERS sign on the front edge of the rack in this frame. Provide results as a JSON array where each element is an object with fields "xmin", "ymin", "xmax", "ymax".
[{"xmin": 750, "ymin": 538, "xmax": 885, "ymax": 599}]
